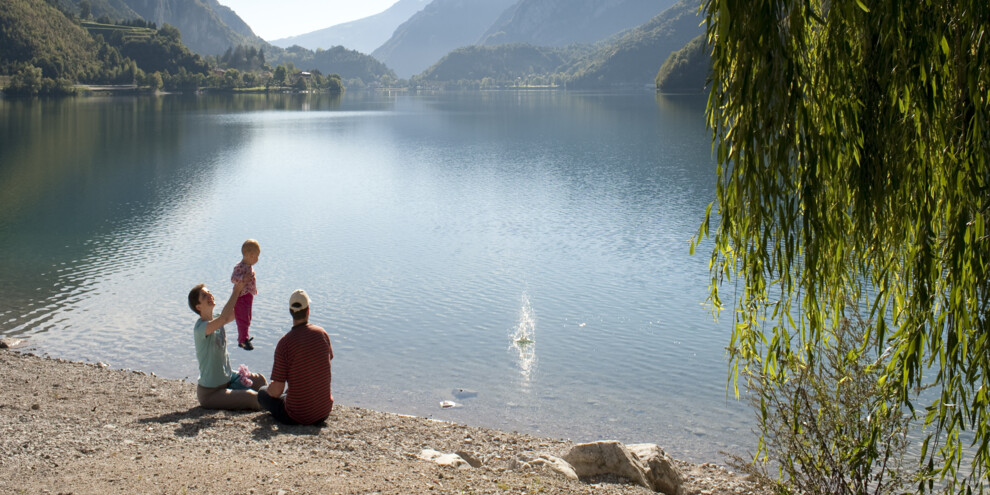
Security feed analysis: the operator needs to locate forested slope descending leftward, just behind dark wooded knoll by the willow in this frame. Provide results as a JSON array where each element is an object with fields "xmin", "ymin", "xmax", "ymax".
[{"xmin": 566, "ymin": 0, "xmax": 704, "ymax": 88}]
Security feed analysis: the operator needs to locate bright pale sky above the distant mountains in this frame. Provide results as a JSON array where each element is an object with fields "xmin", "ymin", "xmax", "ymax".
[{"xmin": 218, "ymin": 0, "xmax": 398, "ymax": 41}]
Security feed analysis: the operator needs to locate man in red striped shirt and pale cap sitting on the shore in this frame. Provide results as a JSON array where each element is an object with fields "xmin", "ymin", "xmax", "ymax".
[{"xmin": 258, "ymin": 289, "xmax": 333, "ymax": 425}]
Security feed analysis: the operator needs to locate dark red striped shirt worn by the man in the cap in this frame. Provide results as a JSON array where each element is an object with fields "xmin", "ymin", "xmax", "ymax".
[{"xmin": 272, "ymin": 323, "xmax": 333, "ymax": 425}]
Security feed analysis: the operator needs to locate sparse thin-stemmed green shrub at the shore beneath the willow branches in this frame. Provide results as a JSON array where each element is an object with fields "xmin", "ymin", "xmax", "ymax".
[{"xmin": 732, "ymin": 314, "xmax": 915, "ymax": 495}]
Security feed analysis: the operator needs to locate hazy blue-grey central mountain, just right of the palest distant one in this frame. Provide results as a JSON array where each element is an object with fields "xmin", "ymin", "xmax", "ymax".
[{"xmin": 371, "ymin": 0, "xmax": 517, "ymax": 78}]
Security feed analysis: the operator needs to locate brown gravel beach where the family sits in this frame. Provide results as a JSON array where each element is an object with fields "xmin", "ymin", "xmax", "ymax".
[{"xmin": 0, "ymin": 349, "xmax": 757, "ymax": 495}]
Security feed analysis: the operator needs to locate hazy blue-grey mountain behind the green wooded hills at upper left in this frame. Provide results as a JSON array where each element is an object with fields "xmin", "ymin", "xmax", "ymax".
[{"xmin": 55, "ymin": 0, "xmax": 265, "ymax": 55}]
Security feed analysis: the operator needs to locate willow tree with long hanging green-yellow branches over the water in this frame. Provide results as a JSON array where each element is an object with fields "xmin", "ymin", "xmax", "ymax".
[{"xmin": 699, "ymin": 0, "xmax": 990, "ymax": 490}]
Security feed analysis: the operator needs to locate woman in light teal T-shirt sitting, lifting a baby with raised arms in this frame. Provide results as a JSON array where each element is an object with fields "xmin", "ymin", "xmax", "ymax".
[{"xmin": 189, "ymin": 281, "xmax": 266, "ymax": 411}]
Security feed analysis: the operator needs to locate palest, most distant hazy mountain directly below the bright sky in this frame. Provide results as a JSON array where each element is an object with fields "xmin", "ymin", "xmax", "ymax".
[{"xmin": 270, "ymin": 0, "xmax": 430, "ymax": 53}]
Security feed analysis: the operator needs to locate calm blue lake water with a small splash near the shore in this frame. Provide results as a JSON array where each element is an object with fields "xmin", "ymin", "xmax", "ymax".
[{"xmin": 0, "ymin": 92, "xmax": 755, "ymax": 461}]
